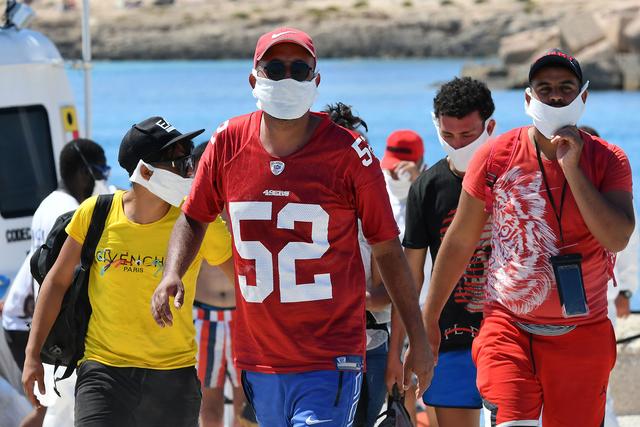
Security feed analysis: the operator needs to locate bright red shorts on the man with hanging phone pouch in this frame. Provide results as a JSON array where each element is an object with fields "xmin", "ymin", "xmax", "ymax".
[{"xmin": 472, "ymin": 316, "xmax": 616, "ymax": 427}]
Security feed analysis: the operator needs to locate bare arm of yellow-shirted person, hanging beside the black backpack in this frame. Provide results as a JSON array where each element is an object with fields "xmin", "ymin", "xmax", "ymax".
[{"xmin": 22, "ymin": 237, "xmax": 82, "ymax": 407}]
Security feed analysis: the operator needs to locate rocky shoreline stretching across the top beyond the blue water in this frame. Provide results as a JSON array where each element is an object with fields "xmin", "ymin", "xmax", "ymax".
[{"xmin": 17, "ymin": 0, "xmax": 640, "ymax": 90}]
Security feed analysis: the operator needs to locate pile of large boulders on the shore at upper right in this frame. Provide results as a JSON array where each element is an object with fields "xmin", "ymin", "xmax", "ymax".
[{"xmin": 463, "ymin": 3, "xmax": 640, "ymax": 91}]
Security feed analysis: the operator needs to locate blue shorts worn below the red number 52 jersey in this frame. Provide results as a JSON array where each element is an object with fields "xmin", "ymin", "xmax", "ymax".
[{"xmin": 242, "ymin": 371, "xmax": 363, "ymax": 427}]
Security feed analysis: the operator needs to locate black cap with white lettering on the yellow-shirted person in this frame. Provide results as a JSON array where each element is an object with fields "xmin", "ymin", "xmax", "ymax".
[{"xmin": 118, "ymin": 116, "xmax": 204, "ymax": 174}]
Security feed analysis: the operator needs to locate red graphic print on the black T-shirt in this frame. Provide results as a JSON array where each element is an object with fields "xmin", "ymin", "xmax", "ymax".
[{"xmin": 440, "ymin": 208, "xmax": 491, "ymax": 320}]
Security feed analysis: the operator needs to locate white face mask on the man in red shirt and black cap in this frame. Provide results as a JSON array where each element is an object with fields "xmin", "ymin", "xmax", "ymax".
[{"xmin": 524, "ymin": 82, "xmax": 589, "ymax": 139}]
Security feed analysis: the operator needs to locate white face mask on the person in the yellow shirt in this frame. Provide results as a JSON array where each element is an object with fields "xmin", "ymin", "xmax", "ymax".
[{"xmin": 129, "ymin": 160, "xmax": 193, "ymax": 207}]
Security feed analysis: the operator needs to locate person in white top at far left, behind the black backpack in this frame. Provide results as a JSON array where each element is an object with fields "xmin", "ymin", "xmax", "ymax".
[{"xmin": 2, "ymin": 139, "xmax": 111, "ymax": 427}]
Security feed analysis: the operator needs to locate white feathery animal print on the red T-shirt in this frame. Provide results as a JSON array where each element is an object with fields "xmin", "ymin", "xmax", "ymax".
[{"xmin": 487, "ymin": 167, "xmax": 559, "ymax": 315}]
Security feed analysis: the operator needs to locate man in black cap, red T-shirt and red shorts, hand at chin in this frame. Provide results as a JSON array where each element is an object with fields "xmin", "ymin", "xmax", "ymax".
[{"xmin": 425, "ymin": 49, "xmax": 635, "ymax": 427}]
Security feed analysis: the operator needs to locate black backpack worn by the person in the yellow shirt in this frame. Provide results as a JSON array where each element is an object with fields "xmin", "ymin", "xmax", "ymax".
[{"xmin": 31, "ymin": 194, "xmax": 113, "ymax": 396}]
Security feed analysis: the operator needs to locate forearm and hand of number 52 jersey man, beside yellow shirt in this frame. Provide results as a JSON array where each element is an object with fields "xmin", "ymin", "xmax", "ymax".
[{"xmin": 151, "ymin": 213, "xmax": 206, "ymax": 327}]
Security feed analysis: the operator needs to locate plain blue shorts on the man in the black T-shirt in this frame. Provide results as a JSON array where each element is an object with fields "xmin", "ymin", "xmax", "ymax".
[{"xmin": 422, "ymin": 348, "xmax": 482, "ymax": 409}]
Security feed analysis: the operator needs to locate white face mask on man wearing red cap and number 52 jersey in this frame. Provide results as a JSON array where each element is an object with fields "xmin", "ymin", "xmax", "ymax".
[{"xmin": 251, "ymin": 70, "xmax": 318, "ymax": 120}]
